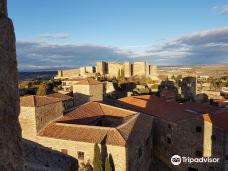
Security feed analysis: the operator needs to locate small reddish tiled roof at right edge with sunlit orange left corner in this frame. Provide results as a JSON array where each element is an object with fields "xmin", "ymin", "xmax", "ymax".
[{"xmin": 200, "ymin": 111, "xmax": 228, "ymax": 131}]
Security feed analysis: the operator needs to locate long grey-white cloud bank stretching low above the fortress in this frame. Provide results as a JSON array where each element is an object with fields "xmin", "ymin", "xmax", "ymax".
[{"xmin": 17, "ymin": 27, "xmax": 228, "ymax": 70}]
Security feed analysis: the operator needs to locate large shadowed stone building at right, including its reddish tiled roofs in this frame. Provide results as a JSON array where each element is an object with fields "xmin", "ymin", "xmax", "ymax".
[{"xmin": 116, "ymin": 96, "xmax": 228, "ymax": 171}]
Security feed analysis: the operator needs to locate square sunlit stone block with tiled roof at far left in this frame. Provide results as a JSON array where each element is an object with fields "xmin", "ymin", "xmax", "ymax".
[{"xmin": 19, "ymin": 95, "xmax": 64, "ymax": 140}]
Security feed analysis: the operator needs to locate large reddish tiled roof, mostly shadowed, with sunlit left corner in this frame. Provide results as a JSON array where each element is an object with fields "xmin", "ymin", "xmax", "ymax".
[{"xmin": 116, "ymin": 95, "xmax": 218, "ymax": 122}]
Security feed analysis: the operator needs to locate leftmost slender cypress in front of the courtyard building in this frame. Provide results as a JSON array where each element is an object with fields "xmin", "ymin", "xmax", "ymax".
[{"xmin": 93, "ymin": 144, "xmax": 102, "ymax": 171}]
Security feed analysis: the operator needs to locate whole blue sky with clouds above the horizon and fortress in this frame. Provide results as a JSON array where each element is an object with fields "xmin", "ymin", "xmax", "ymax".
[{"xmin": 8, "ymin": 0, "xmax": 228, "ymax": 71}]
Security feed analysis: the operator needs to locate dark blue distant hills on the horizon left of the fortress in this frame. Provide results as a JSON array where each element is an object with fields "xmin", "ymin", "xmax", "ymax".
[{"xmin": 19, "ymin": 71, "xmax": 57, "ymax": 81}]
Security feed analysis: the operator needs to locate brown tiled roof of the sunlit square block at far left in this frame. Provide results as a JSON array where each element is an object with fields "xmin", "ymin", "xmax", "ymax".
[{"xmin": 20, "ymin": 95, "xmax": 61, "ymax": 107}]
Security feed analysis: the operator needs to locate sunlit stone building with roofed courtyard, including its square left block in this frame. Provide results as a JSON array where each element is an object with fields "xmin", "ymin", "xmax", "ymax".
[{"xmin": 20, "ymin": 97, "xmax": 153, "ymax": 171}]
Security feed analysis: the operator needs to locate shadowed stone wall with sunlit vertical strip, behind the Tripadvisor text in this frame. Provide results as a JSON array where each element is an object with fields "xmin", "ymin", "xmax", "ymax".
[{"xmin": 154, "ymin": 119, "xmax": 223, "ymax": 171}]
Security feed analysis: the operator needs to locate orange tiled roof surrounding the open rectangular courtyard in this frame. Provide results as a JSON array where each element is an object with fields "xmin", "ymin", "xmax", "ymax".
[{"xmin": 39, "ymin": 102, "xmax": 153, "ymax": 146}]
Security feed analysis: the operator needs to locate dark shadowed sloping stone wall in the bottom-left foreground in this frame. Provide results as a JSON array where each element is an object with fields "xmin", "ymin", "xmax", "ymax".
[{"xmin": 22, "ymin": 139, "xmax": 78, "ymax": 171}]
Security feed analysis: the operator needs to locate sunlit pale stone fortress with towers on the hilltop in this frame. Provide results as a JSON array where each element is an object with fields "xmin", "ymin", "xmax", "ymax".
[{"xmin": 55, "ymin": 61, "xmax": 157, "ymax": 79}]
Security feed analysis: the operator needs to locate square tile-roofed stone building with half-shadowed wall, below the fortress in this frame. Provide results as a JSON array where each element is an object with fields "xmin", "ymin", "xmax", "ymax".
[{"xmin": 73, "ymin": 78, "xmax": 105, "ymax": 106}]
